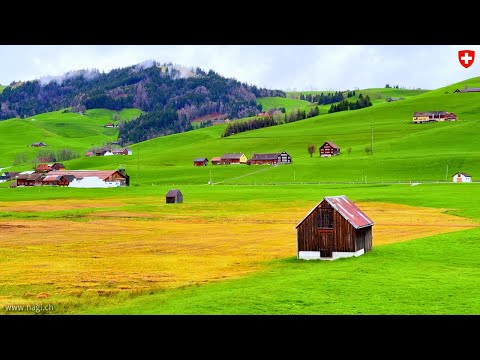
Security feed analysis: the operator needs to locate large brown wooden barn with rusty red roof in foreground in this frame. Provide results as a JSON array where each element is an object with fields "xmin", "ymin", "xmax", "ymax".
[{"xmin": 295, "ymin": 195, "xmax": 374, "ymax": 260}]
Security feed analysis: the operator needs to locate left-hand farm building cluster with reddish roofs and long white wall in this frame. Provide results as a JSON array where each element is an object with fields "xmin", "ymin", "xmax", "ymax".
[{"xmin": 4, "ymin": 167, "xmax": 130, "ymax": 188}]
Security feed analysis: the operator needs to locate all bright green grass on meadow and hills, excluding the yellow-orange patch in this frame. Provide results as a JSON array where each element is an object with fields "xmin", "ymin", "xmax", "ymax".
[{"xmin": 0, "ymin": 77, "xmax": 480, "ymax": 314}]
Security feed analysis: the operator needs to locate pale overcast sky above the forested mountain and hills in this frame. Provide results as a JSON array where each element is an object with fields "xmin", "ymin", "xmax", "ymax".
[{"xmin": 0, "ymin": 45, "xmax": 480, "ymax": 90}]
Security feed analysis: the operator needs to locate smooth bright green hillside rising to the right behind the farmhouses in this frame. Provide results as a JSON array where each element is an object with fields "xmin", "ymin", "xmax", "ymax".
[{"xmin": 3, "ymin": 78, "xmax": 472, "ymax": 184}]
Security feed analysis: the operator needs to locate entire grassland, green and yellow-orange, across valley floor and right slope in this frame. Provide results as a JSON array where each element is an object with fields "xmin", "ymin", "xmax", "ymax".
[{"xmin": 0, "ymin": 77, "xmax": 480, "ymax": 314}]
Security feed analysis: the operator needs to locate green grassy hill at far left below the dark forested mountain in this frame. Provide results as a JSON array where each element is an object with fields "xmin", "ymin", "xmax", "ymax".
[{"xmin": 0, "ymin": 109, "xmax": 140, "ymax": 170}]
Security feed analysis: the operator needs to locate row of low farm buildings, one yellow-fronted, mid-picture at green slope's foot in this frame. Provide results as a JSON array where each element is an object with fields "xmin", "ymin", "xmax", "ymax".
[{"xmin": 193, "ymin": 151, "xmax": 292, "ymax": 166}]
